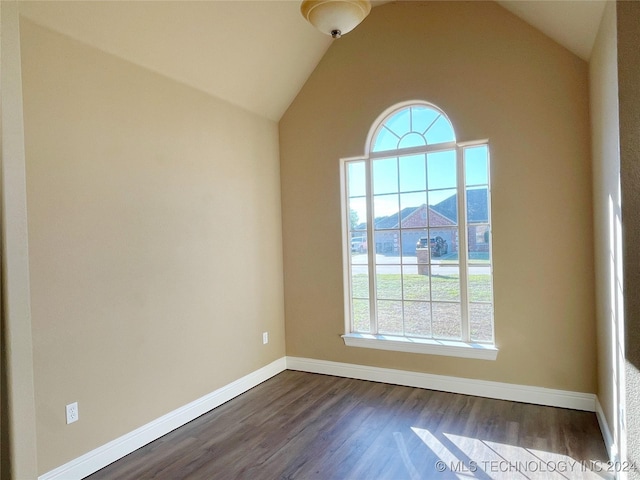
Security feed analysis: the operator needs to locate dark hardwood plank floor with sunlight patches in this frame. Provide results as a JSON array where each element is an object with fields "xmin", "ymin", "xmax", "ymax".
[{"xmin": 87, "ymin": 371, "xmax": 609, "ymax": 480}]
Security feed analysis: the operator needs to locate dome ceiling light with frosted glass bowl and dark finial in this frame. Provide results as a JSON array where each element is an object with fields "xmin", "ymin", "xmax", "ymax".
[{"xmin": 300, "ymin": 0, "xmax": 371, "ymax": 38}]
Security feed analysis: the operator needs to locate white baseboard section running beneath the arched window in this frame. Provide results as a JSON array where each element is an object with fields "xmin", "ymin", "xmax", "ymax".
[{"xmin": 287, "ymin": 357, "xmax": 596, "ymax": 412}]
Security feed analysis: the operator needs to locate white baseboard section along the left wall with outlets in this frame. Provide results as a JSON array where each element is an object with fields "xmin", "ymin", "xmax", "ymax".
[{"xmin": 38, "ymin": 357, "xmax": 286, "ymax": 480}]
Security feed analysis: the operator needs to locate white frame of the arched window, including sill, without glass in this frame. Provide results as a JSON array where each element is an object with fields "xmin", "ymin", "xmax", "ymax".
[{"xmin": 340, "ymin": 101, "xmax": 498, "ymax": 360}]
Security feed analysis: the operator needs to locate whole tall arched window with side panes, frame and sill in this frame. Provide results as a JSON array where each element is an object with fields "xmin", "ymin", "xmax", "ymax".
[{"xmin": 341, "ymin": 102, "xmax": 497, "ymax": 359}]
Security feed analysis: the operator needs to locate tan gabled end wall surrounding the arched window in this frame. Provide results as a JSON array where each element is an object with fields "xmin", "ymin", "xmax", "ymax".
[{"xmin": 280, "ymin": 2, "xmax": 596, "ymax": 392}]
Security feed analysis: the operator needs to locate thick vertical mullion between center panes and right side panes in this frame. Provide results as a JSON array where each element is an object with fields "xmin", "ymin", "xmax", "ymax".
[{"xmin": 456, "ymin": 147, "xmax": 471, "ymax": 342}]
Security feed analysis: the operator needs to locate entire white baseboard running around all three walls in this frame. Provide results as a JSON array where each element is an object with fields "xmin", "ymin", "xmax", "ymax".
[{"xmin": 38, "ymin": 357, "xmax": 600, "ymax": 480}]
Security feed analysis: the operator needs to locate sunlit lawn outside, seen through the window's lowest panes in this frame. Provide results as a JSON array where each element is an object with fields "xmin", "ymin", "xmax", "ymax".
[{"xmin": 353, "ymin": 274, "xmax": 492, "ymax": 341}]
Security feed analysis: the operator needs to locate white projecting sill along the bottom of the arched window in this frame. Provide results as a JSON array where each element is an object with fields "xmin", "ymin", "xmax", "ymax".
[{"xmin": 342, "ymin": 333, "xmax": 498, "ymax": 360}]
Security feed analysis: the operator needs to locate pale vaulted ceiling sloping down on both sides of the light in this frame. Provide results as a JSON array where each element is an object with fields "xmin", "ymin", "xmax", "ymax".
[{"xmin": 20, "ymin": 0, "xmax": 606, "ymax": 121}]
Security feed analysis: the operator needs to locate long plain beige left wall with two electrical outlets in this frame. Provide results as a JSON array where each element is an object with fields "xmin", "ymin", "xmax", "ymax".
[{"xmin": 21, "ymin": 20, "xmax": 285, "ymax": 474}]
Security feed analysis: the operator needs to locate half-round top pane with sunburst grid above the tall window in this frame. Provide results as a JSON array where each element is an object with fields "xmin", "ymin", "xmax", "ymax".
[{"xmin": 371, "ymin": 105, "xmax": 456, "ymax": 152}]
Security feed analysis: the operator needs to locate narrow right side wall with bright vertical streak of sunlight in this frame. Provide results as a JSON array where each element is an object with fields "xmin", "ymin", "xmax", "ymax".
[{"xmin": 589, "ymin": 2, "xmax": 624, "ymax": 464}]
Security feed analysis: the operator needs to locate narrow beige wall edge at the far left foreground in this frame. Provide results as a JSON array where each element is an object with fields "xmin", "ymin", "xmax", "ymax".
[{"xmin": 0, "ymin": 1, "xmax": 37, "ymax": 479}]
